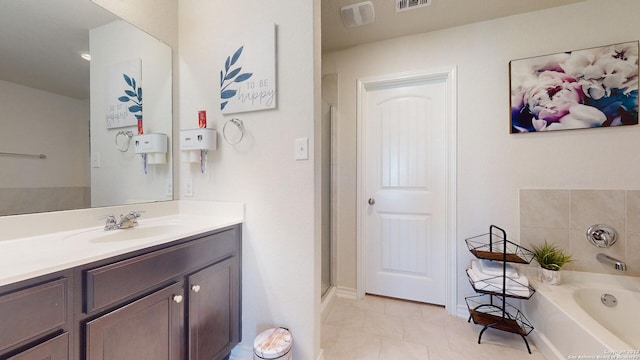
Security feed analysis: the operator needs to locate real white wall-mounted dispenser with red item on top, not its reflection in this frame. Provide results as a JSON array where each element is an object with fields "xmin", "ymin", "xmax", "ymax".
[{"xmin": 180, "ymin": 128, "xmax": 217, "ymax": 174}]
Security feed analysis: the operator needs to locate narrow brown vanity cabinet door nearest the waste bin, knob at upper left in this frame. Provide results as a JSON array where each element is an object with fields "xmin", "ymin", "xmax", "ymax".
[{"xmin": 189, "ymin": 257, "xmax": 240, "ymax": 360}]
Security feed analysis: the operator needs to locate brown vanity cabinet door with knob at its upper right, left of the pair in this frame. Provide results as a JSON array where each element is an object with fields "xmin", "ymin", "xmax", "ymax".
[{"xmin": 85, "ymin": 282, "xmax": 184, "ymax": 360}]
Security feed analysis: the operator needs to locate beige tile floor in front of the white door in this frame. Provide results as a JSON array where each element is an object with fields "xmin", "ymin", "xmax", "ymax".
[{"xmin": 321, "ymin": 295, "xmax": 545, "ymax": 360}]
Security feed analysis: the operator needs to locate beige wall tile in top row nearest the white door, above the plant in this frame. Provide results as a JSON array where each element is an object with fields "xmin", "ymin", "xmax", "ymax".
[{"xmin": 520, "ymin": 189, "xmax": 571, "ymax": 229}]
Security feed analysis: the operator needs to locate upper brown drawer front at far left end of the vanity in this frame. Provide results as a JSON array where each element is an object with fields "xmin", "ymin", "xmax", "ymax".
[{"xmin": 0, "ymin": 278, "xmax": 67, "ymax": 351}]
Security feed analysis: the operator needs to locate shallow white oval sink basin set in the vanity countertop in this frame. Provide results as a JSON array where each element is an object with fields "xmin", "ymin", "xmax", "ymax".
[{"xmin": 65, "ymin": 224, "xmax": 190, "ymax": 243}]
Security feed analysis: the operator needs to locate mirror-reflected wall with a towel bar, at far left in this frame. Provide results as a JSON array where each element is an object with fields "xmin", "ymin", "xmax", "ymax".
[{"xmin": 0, "ymin": 80, "xmax": 89, "ymax": 188}]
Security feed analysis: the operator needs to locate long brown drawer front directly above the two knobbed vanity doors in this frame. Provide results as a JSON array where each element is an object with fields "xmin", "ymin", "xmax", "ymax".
[{"xmin": 84, "ymin": 228, "xmax": 238, "ymax": 313}]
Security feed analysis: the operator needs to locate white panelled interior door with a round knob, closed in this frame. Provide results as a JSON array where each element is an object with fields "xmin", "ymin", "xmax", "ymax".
[{"xmin": 360, "ymin": 74, "xmax": 447, "ymax": 305}]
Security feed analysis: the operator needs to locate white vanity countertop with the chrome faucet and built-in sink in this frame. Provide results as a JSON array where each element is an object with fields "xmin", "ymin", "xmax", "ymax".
[{"xmin": 0, "ymin": 201, "xmax": 244, "ymax": 286}]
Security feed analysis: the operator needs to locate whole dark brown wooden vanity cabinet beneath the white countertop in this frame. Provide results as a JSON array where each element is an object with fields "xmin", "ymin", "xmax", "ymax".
[{"xmin": 0, "ymin": 225, "xmax": 241, "ymax": 360}]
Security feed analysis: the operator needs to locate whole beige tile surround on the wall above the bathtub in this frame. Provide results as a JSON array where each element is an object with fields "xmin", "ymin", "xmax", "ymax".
[{"xmin": 520, "ymin": 189, "xmax": 640, "ymax": 276}]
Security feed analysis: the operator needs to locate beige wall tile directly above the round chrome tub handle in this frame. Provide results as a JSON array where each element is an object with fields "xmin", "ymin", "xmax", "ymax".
[{"xmin": 571, "ymin": 190, "xmax": 626, "ymax": 234}]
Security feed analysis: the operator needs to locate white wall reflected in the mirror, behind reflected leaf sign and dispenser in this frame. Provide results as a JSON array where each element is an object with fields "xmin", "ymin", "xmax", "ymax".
[{"xmin": 89, "ymin": 20, "xmax": 173, "ymax": 206}]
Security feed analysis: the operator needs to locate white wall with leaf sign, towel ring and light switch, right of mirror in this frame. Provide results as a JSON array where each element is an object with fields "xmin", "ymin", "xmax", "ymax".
[{"xmin": 178, "ymin": 0, "xmax": 320, "ymax": 359}]
